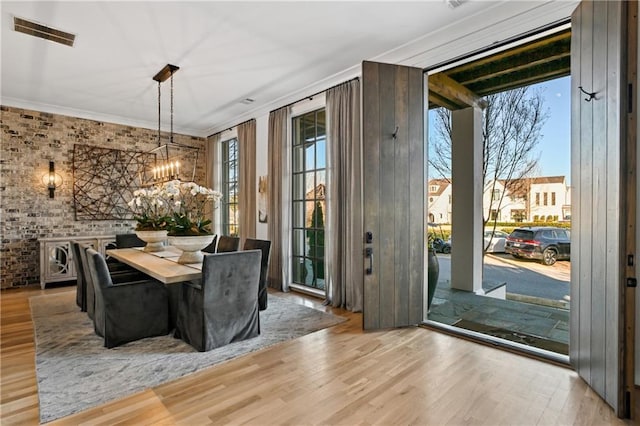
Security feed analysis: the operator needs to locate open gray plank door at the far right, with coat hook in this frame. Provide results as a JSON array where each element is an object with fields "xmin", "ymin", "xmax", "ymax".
[{"xmin": 570, "ymin": 0, "xmax": 639, "ymax": 417}]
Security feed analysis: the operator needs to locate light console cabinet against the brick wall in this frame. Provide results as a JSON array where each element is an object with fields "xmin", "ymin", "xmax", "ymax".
[{"xmin": 38, "ymin": 235, "xmax": 116, "ymax": 289}]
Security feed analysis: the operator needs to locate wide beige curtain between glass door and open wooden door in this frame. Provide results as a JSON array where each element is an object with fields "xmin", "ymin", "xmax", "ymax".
[{"xmin": 325, "ymin": 80, "xmax": 364, "ymax": 312}]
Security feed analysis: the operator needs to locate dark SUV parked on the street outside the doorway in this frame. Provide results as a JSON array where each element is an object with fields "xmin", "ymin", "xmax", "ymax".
[{"xmin": 504, "ymin": 226, "xmax": 571, "ymax": 265}]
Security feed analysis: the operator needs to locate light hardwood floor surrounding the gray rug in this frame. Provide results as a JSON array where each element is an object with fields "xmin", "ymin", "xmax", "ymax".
[{"xmin": 0, "ymin": 287, "xmax": 631, "ymax": 425}]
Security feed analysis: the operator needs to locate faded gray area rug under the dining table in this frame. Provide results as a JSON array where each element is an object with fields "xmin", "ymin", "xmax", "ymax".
[{"xmin": 29, "ymin": 291, "xmax": 345, "ymax": 423}]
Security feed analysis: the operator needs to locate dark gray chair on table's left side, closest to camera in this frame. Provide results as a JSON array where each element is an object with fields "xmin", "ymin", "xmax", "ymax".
[{"xmin": 86, "ymin": 248, "xmax": 169, "ymax": 348}]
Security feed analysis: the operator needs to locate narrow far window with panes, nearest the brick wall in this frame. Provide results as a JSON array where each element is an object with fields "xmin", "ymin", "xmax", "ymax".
[{"xmin": 220, "ymin": 138, "xmax": 239, "ymax": 237}]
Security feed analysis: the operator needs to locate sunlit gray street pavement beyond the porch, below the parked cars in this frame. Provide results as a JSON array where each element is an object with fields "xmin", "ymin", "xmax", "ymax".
[{"xmin": 438, "ymin": 253, "xmax": 571, "ymax": 301}]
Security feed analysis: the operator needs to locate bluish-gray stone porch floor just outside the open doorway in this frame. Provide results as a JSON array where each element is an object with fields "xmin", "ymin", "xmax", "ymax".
[{"xmin": 428, "ymin": 280, "xmax": 569, "ymax": 355}]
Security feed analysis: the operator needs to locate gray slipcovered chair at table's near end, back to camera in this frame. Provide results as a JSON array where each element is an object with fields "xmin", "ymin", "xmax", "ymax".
[{"xmin": 175, "ymin": 250, "xmax": 262, "ymax": 352}]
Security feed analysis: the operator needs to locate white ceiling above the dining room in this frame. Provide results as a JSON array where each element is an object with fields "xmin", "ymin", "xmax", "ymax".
[{"xmin": 0, "ymin": 0, "xmax": 575, "ymax": 136}]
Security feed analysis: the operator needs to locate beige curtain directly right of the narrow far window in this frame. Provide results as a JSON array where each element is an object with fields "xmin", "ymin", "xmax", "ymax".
[{"xmin": 238, "ymin": 120, "xmax": 258, "ymax": 247}]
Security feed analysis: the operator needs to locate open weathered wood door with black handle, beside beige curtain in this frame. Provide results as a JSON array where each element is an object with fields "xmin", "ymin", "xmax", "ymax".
[{"xmin": 362, "ymin": 61, "xmax": 426, "ymax": 330}]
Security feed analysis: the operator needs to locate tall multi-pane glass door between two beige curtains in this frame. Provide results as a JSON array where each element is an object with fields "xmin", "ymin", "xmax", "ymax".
[{"xmin": 291, "ymin": 109, "xmax": 327, "ymax": 290}]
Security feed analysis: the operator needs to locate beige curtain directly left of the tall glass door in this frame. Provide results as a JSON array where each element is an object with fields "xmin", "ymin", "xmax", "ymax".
[{"xmin": 267, "ymin": 107, "xmax": 291, "ymax": 291}]
